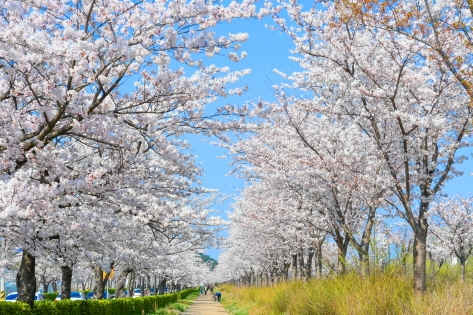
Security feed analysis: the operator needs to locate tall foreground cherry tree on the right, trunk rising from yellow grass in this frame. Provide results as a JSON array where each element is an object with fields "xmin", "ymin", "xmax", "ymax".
[{"xmin": 275, "ymin": 2, "xmax": 471, "ymax": 292}]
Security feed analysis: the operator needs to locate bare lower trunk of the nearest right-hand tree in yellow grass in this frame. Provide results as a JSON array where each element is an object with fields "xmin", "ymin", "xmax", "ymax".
[{"xmin": 413, "ymin": 227, "xmax": 427, "ymax": 293}]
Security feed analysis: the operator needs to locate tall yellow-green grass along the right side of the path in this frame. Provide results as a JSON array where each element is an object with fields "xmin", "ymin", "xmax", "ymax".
[{"xmin": 220, "ymin": 270, "xmax": 473, "ymax": 315}]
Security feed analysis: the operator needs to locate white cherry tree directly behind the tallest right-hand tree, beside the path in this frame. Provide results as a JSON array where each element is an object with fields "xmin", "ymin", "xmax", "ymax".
[{"xmin": 232, "ymin": 103, "xmax": 389, "ymax": 274}]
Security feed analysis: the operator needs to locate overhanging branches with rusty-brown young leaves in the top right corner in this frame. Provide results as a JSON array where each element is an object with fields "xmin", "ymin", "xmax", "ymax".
[{"xmin": 334, "ymin": 0, "xmax": 473, "ymax": 106}]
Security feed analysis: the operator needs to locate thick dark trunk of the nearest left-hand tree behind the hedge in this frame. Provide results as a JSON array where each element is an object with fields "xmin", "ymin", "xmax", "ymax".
[{"xmin": 16, "ymin": 250, "xmax": 36, "ymax": 309}]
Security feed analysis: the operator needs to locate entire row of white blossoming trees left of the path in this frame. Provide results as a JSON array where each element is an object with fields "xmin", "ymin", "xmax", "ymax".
[{"xmin": 0, "ymin": 0, "xmax": 267, "ymax": 305}]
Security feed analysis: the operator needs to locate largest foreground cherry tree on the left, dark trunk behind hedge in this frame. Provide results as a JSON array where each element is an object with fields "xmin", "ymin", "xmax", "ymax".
[{"xmin": 0, "ymin": 0, "xmax": 268, "ymax": 306}]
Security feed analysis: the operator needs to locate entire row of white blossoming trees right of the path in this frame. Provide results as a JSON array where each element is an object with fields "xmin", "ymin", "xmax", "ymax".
[{"xmin": 215, "ymin": 0, "xmax": 473, "ymax": 292}]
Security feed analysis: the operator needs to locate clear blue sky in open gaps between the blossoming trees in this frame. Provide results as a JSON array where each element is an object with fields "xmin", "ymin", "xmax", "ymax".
[{"xmin": 186, "ymin": 19, "xmax": 473, "ymax": 259}]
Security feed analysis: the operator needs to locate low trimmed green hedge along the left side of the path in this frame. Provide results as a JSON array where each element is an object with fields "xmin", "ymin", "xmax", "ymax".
[{"xmin": 0, "ymin": 290, "xmax": 188, "ymax": 315}]
